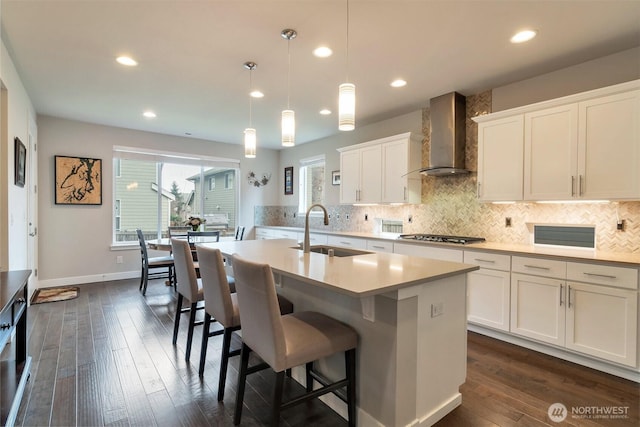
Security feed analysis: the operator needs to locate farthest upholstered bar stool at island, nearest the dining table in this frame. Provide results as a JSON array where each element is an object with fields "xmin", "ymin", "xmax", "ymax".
[{"xmin": 171, "ymin": 237, "xmax": 204, "ymax": 361}]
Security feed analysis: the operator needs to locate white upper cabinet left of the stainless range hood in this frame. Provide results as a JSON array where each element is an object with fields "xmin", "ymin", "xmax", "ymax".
[{"xmin": 338, "ymin": 133, "xmax": 422, "ymax": 204}]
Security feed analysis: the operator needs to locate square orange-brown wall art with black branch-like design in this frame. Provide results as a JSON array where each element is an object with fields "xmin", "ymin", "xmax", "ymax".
[{"xmin": 55, "ymin": 156, "xmax": 102, "ymax": 205}]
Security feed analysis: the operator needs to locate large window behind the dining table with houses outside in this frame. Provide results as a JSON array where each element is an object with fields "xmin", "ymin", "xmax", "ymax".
[{"xmin": 113, "ymin": 147, "xmax": 239, "ymax": 245}]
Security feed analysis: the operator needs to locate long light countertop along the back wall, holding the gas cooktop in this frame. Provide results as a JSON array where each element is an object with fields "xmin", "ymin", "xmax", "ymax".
[{"xmin": 257, "ymin": 226, "xmax": 640, "ymax": 268}]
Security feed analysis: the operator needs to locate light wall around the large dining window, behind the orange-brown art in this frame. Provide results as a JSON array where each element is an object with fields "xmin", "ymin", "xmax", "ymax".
[{"xmin": 38, "ymin": 116, "xmax": 278, "ymax": 287}]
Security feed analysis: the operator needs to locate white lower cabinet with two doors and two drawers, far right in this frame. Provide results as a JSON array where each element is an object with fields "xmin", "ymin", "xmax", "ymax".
[{"xmin": 510, "ymin": 257, "xmax": 638, "ymax": 367}]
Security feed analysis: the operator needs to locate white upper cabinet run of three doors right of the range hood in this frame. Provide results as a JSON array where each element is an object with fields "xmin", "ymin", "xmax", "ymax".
[{"xmin": 474, "ymin": 80, "xmax": 640, "ymax": 201}]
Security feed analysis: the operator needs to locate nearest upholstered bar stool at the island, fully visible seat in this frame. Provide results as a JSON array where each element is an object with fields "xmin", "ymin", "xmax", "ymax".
[{"xmin": 233, "ymin": 254, "xmax": 358, "ymax": 426}]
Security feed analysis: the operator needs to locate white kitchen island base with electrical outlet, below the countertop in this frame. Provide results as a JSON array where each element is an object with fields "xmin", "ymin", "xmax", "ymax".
[{"xmin": 276, "ymin": 274, "xmax": 467, "ymax": 427}]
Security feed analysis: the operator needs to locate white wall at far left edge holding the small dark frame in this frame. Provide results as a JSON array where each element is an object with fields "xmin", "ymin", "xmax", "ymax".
[{"xmin": 0, "ymin": 42, "xmax": 35, "ymax": 270}]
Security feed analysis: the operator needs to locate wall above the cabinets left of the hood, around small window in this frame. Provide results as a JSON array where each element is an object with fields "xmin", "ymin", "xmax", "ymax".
[{"xmin": 278, "ymin": 110, "xmax": 422, "ymax": 206}]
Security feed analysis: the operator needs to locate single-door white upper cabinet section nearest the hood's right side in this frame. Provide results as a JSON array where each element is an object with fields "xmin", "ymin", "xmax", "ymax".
[{"xmin": 478, "ymin": 115, "xmax": 523, "ymax": 202}]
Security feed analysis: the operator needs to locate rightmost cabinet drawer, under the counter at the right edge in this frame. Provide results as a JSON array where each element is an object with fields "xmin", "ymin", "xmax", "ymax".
[{"xmin": 567, "ymin": 262, "xmax": 638, "ymax": 289}]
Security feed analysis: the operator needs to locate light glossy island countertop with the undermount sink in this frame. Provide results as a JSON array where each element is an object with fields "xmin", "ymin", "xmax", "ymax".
[{"xmin": 203, "ymin": 239, "xmax": 478, "ymax": 297}]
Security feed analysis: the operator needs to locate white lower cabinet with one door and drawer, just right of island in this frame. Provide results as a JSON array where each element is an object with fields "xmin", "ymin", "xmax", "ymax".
[{"xmin": 464, "ymin": 250, "xmax": 511, "ymax": 331}]
